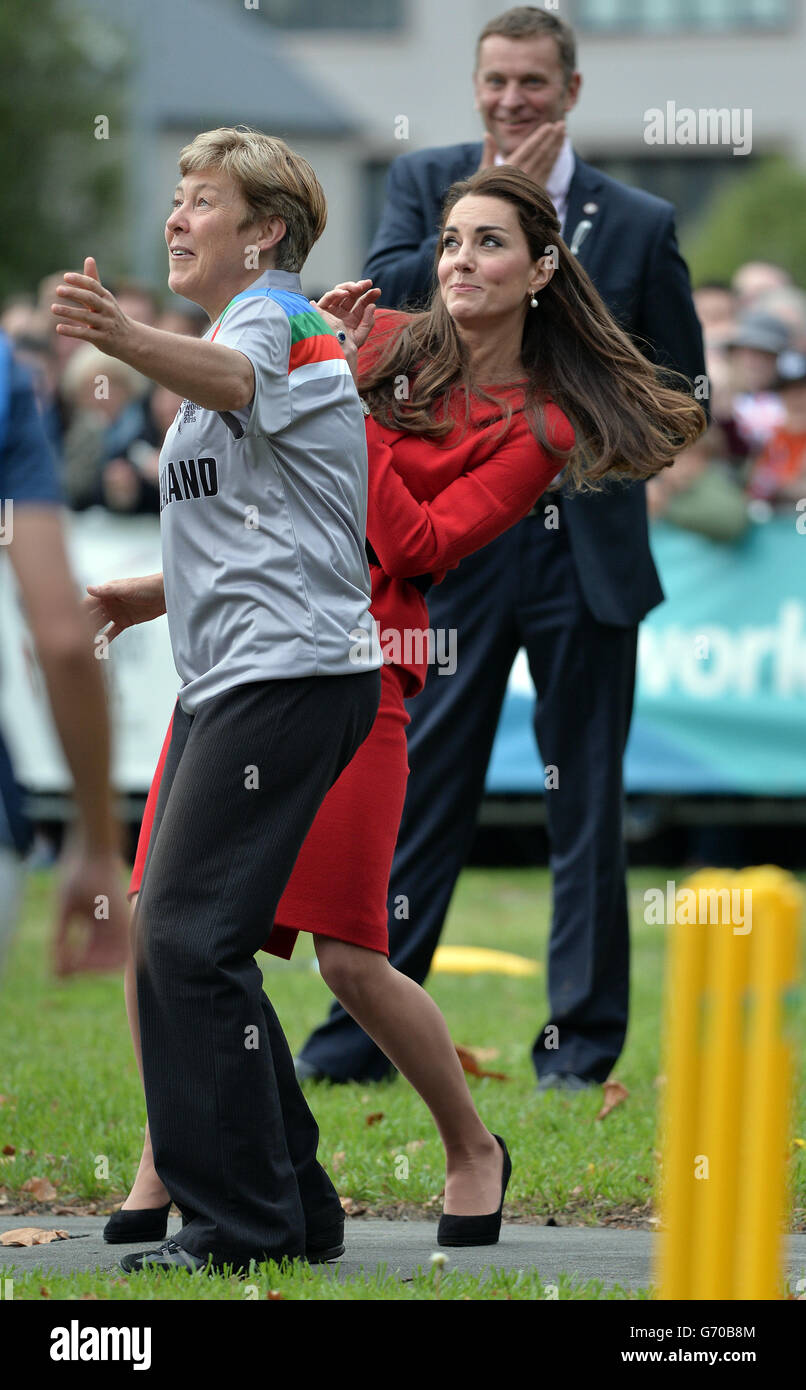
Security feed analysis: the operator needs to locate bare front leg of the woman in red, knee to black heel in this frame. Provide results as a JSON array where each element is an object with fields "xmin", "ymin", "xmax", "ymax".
[{"xmin": 314, "ymin": 935, "xmax": 503, "ymax": 1216}]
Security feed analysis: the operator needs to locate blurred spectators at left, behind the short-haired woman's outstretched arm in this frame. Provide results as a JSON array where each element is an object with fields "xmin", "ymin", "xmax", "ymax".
[{"xmin": 0, "ymin": 275, "xmax": 208, "ymax": 516}]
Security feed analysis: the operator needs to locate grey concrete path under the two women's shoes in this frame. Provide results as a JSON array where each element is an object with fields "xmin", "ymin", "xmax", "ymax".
[{"xmin": 0, "ymin": 1213, "xmax": 806, "ymax": 1289}]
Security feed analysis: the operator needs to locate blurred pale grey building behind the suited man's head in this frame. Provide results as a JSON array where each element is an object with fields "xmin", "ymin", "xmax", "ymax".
[{"xmin": 83, "ymin": 0, "xmax": 806, "ymax": 293}]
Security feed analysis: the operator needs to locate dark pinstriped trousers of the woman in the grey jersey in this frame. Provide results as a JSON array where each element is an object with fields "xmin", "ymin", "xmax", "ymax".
[{"xmin": 133, "ymin": 671, "xmax": 381, "ymax": 1264}]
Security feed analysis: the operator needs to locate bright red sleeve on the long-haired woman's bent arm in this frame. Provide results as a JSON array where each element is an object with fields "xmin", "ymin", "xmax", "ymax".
[{"xmin": 367, "ymin": 404, "xmax": 574, "ymax": 582}]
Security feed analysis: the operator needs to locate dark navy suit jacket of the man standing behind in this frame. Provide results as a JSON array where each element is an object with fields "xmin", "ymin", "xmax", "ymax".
[{"xmin": 363, "ymin": 143, "xmax": 705, "ymax": 627}]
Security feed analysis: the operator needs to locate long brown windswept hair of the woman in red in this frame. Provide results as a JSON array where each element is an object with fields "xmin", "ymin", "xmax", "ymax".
[{"xmin": 360, "ymin": 165, "xmax": 706, "ymax": 489}]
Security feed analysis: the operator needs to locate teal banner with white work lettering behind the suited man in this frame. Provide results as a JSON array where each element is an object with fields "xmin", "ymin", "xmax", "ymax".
[{"xmin": 486, "ymin": 513, "xmax": 806, "ymax": 796}]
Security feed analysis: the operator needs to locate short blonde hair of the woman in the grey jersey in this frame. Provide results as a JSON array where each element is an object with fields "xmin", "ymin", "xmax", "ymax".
[{"xmin": 179, "ymin": 125, "xmax": 328, "ymax": 271}]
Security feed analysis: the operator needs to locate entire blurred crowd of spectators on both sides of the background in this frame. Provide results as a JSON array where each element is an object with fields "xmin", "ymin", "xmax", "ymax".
[{"xmin": 0, "ymin": 261, "xmax": 806, "ymax": 541}]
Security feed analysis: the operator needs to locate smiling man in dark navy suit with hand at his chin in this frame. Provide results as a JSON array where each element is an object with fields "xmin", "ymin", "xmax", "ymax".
[{"xmin": 297, "ymin": 6, "xmax": 705, "ymax": 1090}]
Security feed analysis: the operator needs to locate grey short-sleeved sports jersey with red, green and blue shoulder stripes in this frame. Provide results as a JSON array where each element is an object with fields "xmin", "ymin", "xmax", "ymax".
[{"xmin": 160, "ymin": 270, "xmax": 381, "ymax": 713}]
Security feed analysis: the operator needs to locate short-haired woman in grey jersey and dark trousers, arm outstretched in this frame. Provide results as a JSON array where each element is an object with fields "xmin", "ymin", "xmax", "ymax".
[{"xmin": 53, "ymin": 128, "xmax": 379, "ymax": 1269}]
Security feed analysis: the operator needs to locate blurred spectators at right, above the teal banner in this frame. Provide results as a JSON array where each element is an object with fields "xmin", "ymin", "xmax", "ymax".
[{"xmin": 648, "ymin": 261, "xmax": 806, "ymax": 541}]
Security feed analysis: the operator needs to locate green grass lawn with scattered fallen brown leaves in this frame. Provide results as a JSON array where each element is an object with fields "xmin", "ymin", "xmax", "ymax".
[{"xmin": 0, "ymin": 869, "xmax": 806, "ymax": 1298}]
